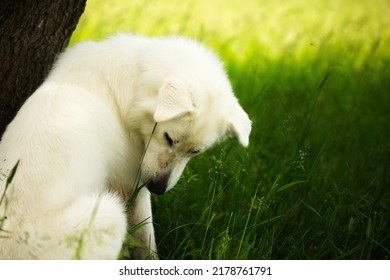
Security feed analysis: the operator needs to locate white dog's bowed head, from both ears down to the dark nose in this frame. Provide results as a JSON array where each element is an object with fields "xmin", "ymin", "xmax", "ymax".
[{"xmin": 141, "ymin": 75, "xmax": 251, "ymax": 194}]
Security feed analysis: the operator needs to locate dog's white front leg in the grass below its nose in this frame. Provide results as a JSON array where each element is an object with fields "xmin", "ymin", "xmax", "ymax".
[{"xmin": 128, "ymin": 188, "xmax": 158, "ymax": 259}]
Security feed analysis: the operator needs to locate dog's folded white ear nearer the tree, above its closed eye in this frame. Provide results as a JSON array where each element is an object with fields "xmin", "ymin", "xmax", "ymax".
[{"xmin": 153, "ymin": 78, "xmax": 195, "ymax": 122}]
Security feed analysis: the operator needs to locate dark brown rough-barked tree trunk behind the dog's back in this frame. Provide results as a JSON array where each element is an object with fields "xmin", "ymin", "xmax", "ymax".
[{"xmin": 0, "ymin": 0, "xmax": 86, "ymax": 136}]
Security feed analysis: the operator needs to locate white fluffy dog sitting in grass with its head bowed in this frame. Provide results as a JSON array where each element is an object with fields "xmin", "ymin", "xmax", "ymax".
[{"xmin": 0, "ymin": 35, "xmax": 251, "ymax": 259}]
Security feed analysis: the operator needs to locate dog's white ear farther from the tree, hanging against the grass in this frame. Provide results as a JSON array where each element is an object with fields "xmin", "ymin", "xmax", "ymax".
[{"xmin": 229, "ymin": 102, "xmax": 252, "ymax": 147}]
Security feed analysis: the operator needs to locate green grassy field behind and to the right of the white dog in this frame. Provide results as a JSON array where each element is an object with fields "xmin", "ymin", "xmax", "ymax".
[{"xmin": 71, "ymin": 0, "xmax": 390, "ymax": 259}]
